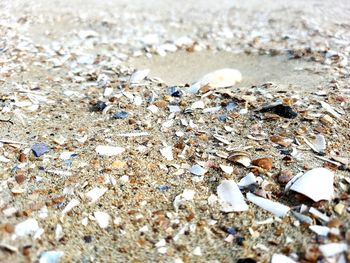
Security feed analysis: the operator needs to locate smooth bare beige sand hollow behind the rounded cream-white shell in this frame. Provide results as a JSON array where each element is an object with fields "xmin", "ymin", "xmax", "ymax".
[{"xmin": 128, "ymin": 51, "xmax": 331, "ymax": 90}]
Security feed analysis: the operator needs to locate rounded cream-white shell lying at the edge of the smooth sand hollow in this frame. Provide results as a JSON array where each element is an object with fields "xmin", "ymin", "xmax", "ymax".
[{"xmin": 200, "ymin": 68, "xmax": 242, "ymax": 88}]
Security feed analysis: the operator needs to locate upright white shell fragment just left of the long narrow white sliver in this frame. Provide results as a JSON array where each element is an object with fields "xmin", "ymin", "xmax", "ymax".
[{"xmin": 217, "ymin": 180, "xmax": 248, "ymax": 213}]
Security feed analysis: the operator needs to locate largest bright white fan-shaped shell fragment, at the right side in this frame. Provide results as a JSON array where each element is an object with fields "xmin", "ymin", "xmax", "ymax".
[{"xmin": 290, "ymin": 168, "xmax": 334, "ymax": 202}]
